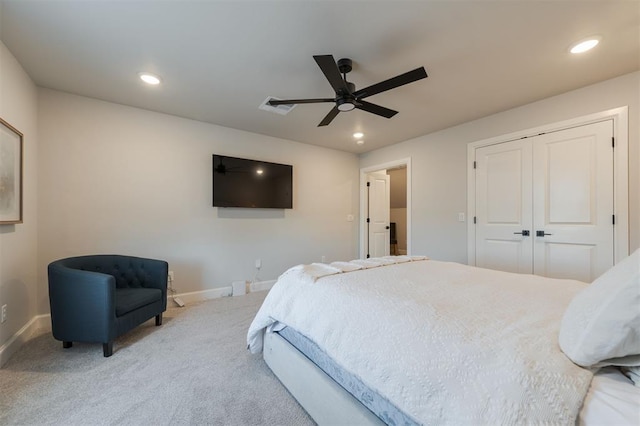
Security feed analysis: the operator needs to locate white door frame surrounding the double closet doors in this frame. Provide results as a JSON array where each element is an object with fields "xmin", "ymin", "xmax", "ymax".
[{"xmin": 467, "ymin": 106, "xmax": 629, "ymax": 266}]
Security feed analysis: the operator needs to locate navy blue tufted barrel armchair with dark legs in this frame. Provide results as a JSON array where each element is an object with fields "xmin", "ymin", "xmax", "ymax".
[{"xmin": 48, "ymin": 255, "xmax": 169, "ymax": 357}]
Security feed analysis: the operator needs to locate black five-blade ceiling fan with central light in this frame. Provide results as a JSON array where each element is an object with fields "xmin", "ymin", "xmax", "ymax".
[{"xmin": 267, "ymin": 55, "xmax": 427, "ymax": 127}]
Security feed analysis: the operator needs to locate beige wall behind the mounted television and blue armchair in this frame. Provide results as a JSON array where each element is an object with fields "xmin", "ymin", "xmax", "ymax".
[{"xmin": 38, "ymin": 89, "xmax": 359, "ymax": 312}]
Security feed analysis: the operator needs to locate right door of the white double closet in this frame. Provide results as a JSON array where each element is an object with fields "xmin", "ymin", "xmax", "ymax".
[{"xmin": 531, "ymin": 121, "xmax": 614, "ymax": 282}]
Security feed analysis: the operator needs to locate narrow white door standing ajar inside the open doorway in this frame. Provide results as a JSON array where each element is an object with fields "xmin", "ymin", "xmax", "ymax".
[{"xmin": 367, "ymin": 172, "xmax": 391, "ymax": 257}]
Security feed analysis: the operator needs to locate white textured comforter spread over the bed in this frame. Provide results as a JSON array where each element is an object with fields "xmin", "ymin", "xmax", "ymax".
[{"xmin": 247, "ymin": 260, "xmax": 593, "ymax": 425}]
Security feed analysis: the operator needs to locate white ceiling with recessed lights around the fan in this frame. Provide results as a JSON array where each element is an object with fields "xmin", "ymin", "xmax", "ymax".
[{"xmin": 0, "ymin": 0, "xmax": 640, "ymax": 153}]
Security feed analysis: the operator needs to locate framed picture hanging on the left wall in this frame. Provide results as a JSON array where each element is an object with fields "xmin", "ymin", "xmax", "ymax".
[{"xmin": 0, "ymin": 118, "xmax": 23, "ymax": 225}]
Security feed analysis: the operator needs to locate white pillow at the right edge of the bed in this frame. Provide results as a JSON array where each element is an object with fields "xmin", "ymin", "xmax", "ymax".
[{"xmin": 559, "ymin": 249, "xmax": 640, "ymax": 367}]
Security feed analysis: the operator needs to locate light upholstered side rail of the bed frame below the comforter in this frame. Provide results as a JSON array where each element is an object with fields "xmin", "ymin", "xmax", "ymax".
[{"xmin": 264, "ymin": 332, "xmax": 384, "ymax": 426}]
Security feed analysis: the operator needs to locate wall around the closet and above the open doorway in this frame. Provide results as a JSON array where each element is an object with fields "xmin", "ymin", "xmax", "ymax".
[{"xmin": 360, "ymin": 72, "xmax": 640, "ymax": 263}]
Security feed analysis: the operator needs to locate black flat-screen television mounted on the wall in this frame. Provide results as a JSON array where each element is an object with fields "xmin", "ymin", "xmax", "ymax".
[{"xmin": 213, "ymin": 154, "xmax": 293, "ymax": 209}]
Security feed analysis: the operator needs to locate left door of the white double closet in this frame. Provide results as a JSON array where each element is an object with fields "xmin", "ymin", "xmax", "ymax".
[{"xmin": 476, "ymin": 139, "xmax": 533, "ymax": 274}]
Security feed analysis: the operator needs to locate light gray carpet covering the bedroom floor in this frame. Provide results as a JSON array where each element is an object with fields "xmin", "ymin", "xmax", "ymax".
[{"xmin": 0, "ymin": 292, "xmax": 314, "ymax": 425}]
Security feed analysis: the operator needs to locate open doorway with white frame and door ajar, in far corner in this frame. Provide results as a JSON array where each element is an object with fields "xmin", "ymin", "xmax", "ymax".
[{"xmin": 360, "ymin": 158, "xmax": 411, "ymax": 259}]
